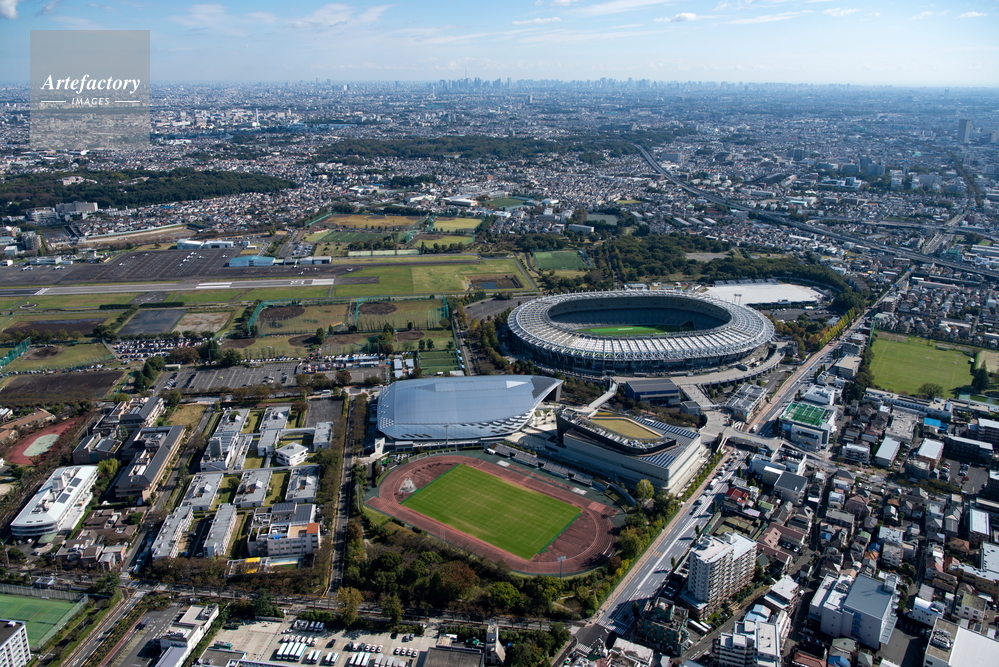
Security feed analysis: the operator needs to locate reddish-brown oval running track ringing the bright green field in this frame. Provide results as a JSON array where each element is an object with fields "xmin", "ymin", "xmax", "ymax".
[{"xmin": 368, "ymin": 456, "xmax": 617, "ymax": 575}]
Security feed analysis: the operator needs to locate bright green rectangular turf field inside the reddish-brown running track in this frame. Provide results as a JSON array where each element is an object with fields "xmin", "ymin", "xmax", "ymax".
[{"xmin": 402, "ymin": 465, "xmax": 579, "ymax": 560}]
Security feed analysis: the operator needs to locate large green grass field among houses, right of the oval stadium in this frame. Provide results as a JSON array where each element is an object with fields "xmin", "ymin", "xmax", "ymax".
[{"xmin": 871, "ymin": 337, "xmax": 971, "ymax": 396}]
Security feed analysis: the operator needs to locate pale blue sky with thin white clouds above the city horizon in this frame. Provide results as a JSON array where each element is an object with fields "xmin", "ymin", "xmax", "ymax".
[{"xmin": 0, "ymin": 0, "xmax": 999, "ymax": 87}]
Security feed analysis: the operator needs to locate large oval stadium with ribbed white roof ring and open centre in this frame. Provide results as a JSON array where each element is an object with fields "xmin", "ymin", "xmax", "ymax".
[{"xmin": 507, "ymin": 291, "xmax": 774, "ymax": 375}]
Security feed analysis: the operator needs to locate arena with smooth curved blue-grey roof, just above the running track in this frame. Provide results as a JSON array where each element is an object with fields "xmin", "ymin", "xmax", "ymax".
[{"xmin": 378, "ymin": 375, "xmax": 562, "ymax": 440}]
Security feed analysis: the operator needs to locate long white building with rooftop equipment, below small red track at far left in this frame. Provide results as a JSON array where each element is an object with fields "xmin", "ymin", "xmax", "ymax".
[{"xmin": 10, "ymin": 466, "xmax": 97, "ymax": 537}]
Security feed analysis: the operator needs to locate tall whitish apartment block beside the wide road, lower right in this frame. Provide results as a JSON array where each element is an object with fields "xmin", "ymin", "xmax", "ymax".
[{"xmin": 683, "ymin": 533, "xmax": 756, "ymax": 618}]
